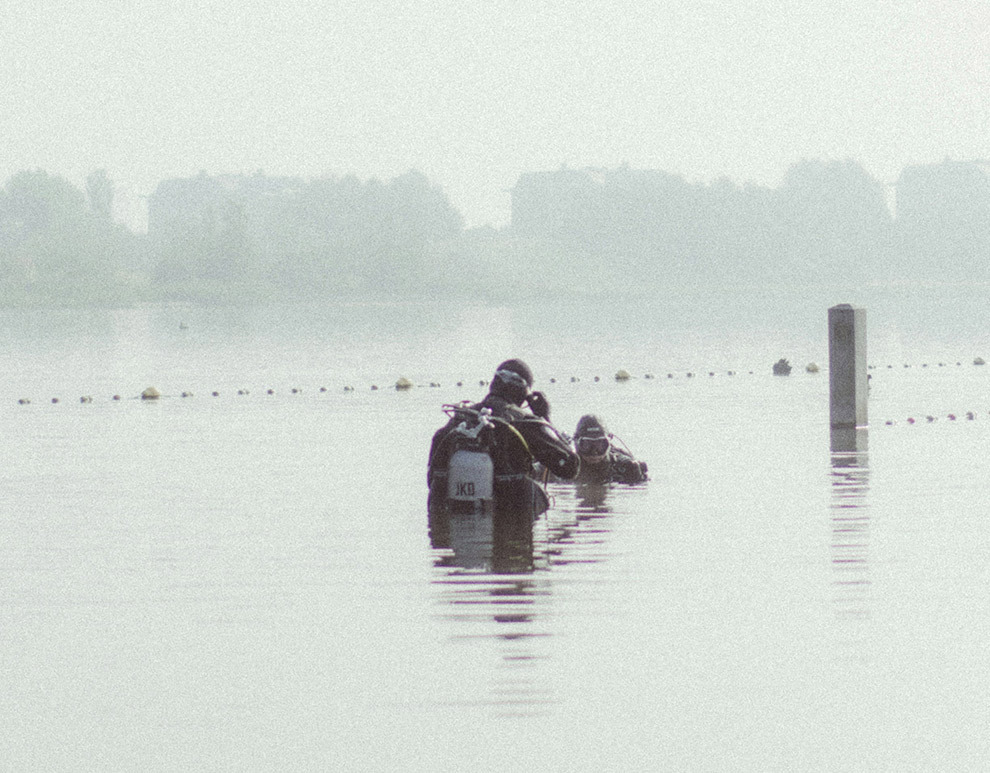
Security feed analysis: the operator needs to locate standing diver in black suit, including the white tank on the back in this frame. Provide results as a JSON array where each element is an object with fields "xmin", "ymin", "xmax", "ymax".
[{"xmin": 427, "ymin": 360, "xmax": 579, "ymax": 514}]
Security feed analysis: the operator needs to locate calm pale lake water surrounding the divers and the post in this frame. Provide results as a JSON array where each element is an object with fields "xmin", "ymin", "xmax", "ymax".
[{"xmin": 0, "ymin": 298, "xmax": 990, "ymax": 771}]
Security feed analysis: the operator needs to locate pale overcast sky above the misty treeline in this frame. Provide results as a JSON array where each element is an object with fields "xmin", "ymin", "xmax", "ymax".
[{"xmin": 0, "ymin": 0, "xmax": 990, "ymax": 226}]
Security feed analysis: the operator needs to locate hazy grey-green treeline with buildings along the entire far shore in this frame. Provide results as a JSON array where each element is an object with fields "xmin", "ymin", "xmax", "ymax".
[{"xmin": 0, "ymin": 161, "xmax": 990, "ymax": 306}]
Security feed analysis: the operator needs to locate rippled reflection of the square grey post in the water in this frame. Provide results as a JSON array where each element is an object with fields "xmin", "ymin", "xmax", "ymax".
[{"xmin": 831, "ymin": 428, "xmax": 871, "ymax": 657}]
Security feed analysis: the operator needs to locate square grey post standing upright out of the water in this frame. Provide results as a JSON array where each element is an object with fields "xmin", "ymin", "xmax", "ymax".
[{"xmin": 828, "ymin": 303, "xmax": 869, "ymax": 427}]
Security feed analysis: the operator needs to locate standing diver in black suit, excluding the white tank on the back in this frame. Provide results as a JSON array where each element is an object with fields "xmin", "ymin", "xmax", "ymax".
[{"xmin": 427, "ymin": 359, "xmax": 580, "ymax": 512}]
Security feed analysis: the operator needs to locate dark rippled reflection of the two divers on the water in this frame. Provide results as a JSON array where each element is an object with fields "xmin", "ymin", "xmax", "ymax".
[{"xmin": 429, "ymin": 486, "xmax": 609, "ymax": 716}]
